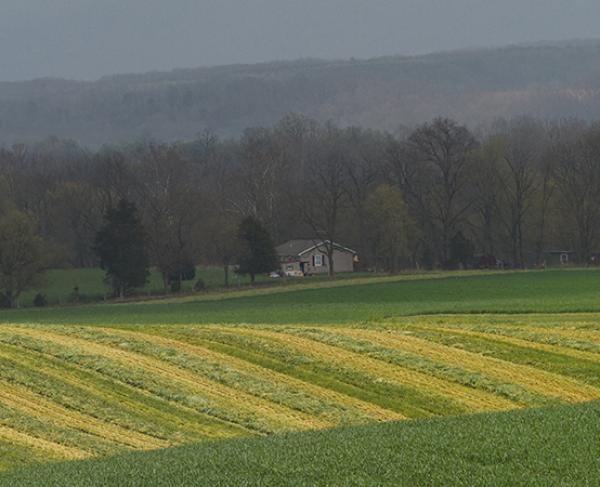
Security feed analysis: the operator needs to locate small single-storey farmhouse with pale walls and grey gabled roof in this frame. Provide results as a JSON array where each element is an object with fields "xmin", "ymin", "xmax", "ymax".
[{"xmin": 276, "ymin": 239, "xmax": 358, "ymax": 275}]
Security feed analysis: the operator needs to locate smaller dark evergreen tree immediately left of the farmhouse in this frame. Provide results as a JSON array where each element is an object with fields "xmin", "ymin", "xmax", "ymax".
[{"xmin": 237, "ymin": 217, "xmax": 279, "ymax": 284}]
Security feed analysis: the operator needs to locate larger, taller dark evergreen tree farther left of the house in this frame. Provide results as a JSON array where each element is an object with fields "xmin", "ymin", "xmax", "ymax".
[{"xmin": 95, "ymin": 199, "xmax": 148, "ymax": 298}]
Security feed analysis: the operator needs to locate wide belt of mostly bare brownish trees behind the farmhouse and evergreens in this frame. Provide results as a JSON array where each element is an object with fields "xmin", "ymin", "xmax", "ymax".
[{"xmin": 0, "ymin": 115, "xmax": 600, "ymax": 302}]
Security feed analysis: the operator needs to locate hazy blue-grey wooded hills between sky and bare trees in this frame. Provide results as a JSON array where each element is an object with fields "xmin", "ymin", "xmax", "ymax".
[{"xmin": 0, "ymin": 40, "xmax": 600, "ymax": 146}]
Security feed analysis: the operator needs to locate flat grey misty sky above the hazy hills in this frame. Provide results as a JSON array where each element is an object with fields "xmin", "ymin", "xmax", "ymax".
[{"xmin": 0, "ymin": 0, "xmax": 600, "ymax": 80}]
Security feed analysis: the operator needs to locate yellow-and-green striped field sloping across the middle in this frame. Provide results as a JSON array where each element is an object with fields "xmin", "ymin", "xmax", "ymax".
[{"xmin": 0, "ymin": 315, "xmax": 600, "ymax": 470}]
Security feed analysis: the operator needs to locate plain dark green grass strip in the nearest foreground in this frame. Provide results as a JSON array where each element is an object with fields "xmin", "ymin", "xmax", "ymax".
[{"xmin": 0, "ymin": 403, "xmax": 600, "ymax": 487}]
